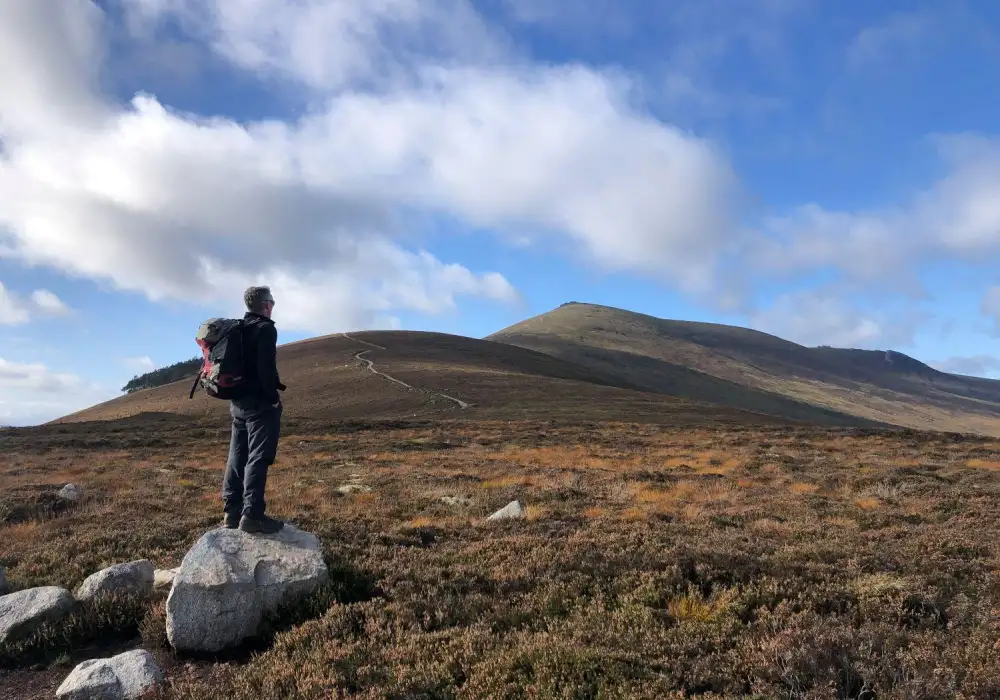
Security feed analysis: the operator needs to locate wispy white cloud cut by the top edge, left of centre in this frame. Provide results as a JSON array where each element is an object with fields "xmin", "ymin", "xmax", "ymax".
[{"xmin": 124, "ymin": 0, "xmax": 507, "ymax": 90}]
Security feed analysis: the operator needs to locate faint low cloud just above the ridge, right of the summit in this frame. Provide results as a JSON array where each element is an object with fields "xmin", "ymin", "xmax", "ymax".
[{"xmin": 750, "ymin": 290, "xmax": 918, "ymax": 349}]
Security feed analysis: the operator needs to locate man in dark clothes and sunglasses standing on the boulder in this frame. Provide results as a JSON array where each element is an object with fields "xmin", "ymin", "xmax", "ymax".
[{"xmin": 222, "ymin": 287, "xmax": 285, "ymax": 535}]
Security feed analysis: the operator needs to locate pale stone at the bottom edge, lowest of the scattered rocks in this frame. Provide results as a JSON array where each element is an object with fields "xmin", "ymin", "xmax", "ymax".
[{"xmin": 56, "ymin": 649, "xmax": 163, "ymax": 700}]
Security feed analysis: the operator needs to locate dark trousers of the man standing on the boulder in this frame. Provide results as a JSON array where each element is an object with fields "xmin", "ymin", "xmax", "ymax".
[{"xmin": 222, "ymin": 405, "xmax": 281, "ymax": 518}]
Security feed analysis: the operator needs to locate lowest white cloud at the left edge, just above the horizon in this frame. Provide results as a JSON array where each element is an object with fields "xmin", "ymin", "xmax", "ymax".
[{"xmin": 0, "ymin": 358, "xmax": 115, "ymax": 425}]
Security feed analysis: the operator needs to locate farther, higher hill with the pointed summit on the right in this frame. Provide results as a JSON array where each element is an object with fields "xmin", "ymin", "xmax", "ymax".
[{"xmin": 488, "ymin": 303, "xmax": 1000, "ymax": 435}]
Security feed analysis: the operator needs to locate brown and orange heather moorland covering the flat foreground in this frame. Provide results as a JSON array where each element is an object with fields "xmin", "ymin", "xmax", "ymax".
[{"xmin": 0, "ymin": 412, "xmax": 1000, "ymax": 700}]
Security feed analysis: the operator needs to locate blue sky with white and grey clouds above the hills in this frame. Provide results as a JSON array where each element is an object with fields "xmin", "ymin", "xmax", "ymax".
[{"xmin": 0, "ymin": 0, "xmax": 1000, "ymax": 425}]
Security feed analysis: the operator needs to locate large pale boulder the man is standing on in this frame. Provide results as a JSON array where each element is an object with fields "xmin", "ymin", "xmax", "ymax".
[{"xmin": 167, "ymin": 523, "xmax": 329, "ymax": 652}]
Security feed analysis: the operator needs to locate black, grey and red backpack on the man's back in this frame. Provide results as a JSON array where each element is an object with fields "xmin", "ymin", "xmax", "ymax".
[{"xmin": 188, "ymin": 318, "xmax": 248, "ymax": 401}]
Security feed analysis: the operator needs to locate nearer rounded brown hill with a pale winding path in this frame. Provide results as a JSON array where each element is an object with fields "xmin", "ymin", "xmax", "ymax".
[{"xmin": 57, "ymin": 331, "xmax": 828, "ymax": 425}]
